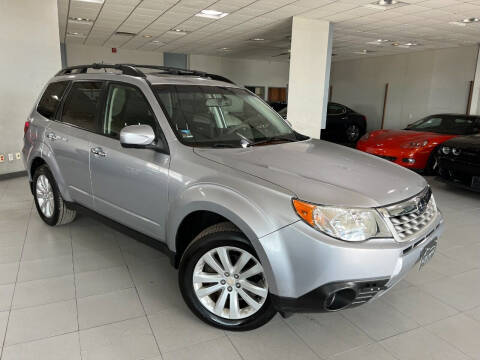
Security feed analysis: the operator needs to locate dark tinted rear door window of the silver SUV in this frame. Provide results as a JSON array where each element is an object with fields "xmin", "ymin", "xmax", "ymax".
[{"xmin": 62, "ymin": 81, "xmax": 104, "ymax": 131}]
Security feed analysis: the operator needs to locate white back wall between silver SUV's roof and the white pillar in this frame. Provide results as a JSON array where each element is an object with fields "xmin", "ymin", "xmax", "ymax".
[{"xmin": 190, "ymin": 55, "xmax": 289, "ymax": 87}]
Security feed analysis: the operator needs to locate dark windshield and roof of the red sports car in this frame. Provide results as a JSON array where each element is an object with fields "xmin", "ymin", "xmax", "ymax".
[{"xmin": 407, "ymin": 115, "xmax": 480, "ymax": 135}]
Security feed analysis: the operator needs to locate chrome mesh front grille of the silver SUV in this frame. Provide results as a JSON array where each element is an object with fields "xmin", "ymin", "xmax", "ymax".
[{"xmin": 385, "ymin": 188, "xmax": 437, "ymax": 242}]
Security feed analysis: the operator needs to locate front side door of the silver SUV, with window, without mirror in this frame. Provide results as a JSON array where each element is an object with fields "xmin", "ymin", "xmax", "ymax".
[{"xmin": 90, "ymin": 83, "xmax": 170, "ymax": 240}]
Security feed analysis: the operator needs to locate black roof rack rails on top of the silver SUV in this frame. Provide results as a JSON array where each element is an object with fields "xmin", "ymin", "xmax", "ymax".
[{"xmin": 55, "ymin": 63, "xmax": 235, "ymax": 84}]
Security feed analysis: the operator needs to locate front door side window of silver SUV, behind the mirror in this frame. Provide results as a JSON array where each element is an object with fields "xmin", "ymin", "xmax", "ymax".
[{"xmin": 102, "ymin": 84, "xmax": 156, "ymax": 138}]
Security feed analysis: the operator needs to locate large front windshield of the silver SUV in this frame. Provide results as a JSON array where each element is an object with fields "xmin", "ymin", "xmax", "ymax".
[{"xmin": 154, "ymin": 85, "xmax": 298, "ymax": 147}]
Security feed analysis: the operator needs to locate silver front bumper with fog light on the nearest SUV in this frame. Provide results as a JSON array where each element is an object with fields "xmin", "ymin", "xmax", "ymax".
[{"xmin": 260, "ymin": 211, "xmax": 443, "ymax": 313}]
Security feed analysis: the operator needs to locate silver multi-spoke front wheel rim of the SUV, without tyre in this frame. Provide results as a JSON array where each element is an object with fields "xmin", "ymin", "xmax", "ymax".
[{"xmin": 192, "ymin": 246, "xmax": 268, "ymax": 319}]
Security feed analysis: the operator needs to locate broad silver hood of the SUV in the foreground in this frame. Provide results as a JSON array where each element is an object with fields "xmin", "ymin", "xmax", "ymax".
[{"xmin": 195, "ymin": 140, "xmax": 427, "ymax": 207}]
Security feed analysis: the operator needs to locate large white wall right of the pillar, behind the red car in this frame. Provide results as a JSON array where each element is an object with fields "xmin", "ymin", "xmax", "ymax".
[{"xmin": 330, "ymin": 46, "xmax": 477, "ymax": 129}]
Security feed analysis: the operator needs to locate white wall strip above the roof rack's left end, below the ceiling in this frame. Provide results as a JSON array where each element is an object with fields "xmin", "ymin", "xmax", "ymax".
[{"xmin": 66, "ymin": 44, "xmax": 163, "ymax": 66}]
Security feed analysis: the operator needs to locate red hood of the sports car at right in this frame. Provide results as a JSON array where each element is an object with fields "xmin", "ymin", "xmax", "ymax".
[{"xmin": 366, "ymin": 130, "xmax": 455, "ymax": 148}]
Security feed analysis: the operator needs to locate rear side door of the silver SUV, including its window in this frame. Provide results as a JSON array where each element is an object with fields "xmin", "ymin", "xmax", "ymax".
[{"xmin": 45, "ymin": 81, "xmax": 105, "ymax": 208}]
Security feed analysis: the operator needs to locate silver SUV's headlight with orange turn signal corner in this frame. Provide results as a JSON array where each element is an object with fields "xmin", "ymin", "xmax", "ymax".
[{"xmin": 293, "ymin": 199, "xmax": 392, "ymax": 241}]
